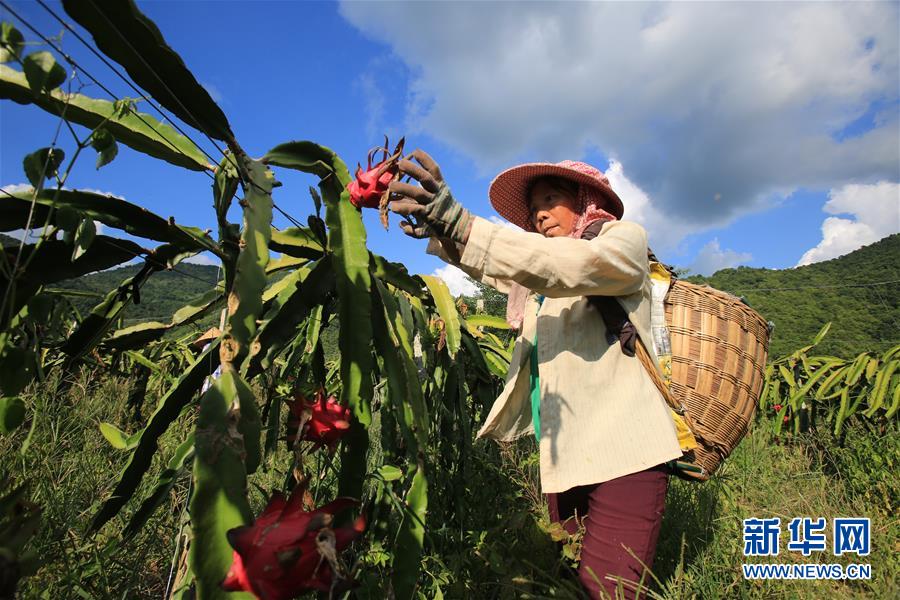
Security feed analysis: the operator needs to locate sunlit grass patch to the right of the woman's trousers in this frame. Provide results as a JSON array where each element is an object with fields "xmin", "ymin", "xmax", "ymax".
[{"xmin": 655, "ymin": 424, "xmax": 900, "ymax": 600}]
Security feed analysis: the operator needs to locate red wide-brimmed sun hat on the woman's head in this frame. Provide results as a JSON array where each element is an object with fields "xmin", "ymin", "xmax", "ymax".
[{"xmin": 488, "ymin": 160, "xmax": 625, "ymax": 231}]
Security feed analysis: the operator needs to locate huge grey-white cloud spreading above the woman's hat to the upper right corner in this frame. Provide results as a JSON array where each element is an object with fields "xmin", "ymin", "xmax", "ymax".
[{"xmin": 340, "ymin": 2, "xmax": 900, "ymax": 239}]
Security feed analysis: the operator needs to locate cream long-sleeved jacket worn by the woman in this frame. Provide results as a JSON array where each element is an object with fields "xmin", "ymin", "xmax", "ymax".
[{"xmin": 428, "ymin": 217, "xmax": 681, "ymax": 493}]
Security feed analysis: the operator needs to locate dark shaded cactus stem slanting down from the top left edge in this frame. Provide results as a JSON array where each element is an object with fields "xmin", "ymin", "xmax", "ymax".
[{"xmin": 63, "ymin": 0, "xmax": 233, "ymax": 140}]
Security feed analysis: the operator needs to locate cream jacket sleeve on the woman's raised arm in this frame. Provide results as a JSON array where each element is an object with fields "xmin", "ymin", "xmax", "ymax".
[{"xmin": 459, "ymin": 217, "xmax": 649, "ymax": 298}]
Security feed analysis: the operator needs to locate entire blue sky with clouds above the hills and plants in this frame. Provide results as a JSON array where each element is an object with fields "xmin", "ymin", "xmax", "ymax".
[{"xmin": 0, "ymin": 0, "xmax": 900, "ymax": 294}]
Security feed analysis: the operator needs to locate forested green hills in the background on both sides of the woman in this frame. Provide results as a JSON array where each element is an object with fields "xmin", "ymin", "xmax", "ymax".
[{"xmin": 55, "ymin": 234, "xmax": 900, "ymax": 357}]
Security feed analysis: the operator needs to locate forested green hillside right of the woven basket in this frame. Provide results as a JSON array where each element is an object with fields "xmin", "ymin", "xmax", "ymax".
[{"xmin": 686, "ymin": 234, "xmax": 900, "ymax": 357}]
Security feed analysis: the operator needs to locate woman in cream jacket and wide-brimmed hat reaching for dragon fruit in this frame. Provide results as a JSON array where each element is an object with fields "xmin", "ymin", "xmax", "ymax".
[{"xmin": 391, "ymin": 150, "xmax": 681, "ymax": 598}]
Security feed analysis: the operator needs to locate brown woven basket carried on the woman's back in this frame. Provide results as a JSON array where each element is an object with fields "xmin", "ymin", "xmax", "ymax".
[{"xmin": 665, "ymin": 280, "xmax": 769, "ymax": 480}]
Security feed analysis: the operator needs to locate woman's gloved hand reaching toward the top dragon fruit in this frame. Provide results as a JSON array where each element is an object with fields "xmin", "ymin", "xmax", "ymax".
[{"xmin": 388, "ymin": 150, "xmax": 474, "ymax": 244}]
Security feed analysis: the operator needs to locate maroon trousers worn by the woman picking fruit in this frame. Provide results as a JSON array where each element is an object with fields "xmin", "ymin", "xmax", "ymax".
[{"xmin": 547, "ymin": 465, "xmax": 669, "ymax": 598}]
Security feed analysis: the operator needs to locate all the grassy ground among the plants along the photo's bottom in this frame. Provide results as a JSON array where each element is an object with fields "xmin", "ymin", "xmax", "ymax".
[{"xmin": 0, "ymin": 372, "xmax": 900, "ymax": 600}]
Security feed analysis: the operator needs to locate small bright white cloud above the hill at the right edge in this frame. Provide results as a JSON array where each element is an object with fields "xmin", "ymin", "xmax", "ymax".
[{"xmin": 797, "ymin": 181, "xmax": 900, "ymax": 267}]
